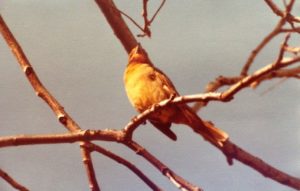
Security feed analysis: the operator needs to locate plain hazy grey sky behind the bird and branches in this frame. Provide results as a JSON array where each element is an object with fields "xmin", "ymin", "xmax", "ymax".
[{"xmin": 0, "ymin": 0, "xmax": 300, "ymax": 191}]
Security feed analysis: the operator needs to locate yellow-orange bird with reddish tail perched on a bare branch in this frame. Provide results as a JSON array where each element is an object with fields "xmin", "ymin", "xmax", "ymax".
[{"xmin": 123, "ymin": 43, "xmax": 229, "ymax": 147}]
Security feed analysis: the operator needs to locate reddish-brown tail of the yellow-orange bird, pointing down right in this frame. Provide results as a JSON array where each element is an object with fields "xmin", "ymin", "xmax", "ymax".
[{"xmin": 180, "ymin": 105, "xmax": 229, "ymax": 147}]
